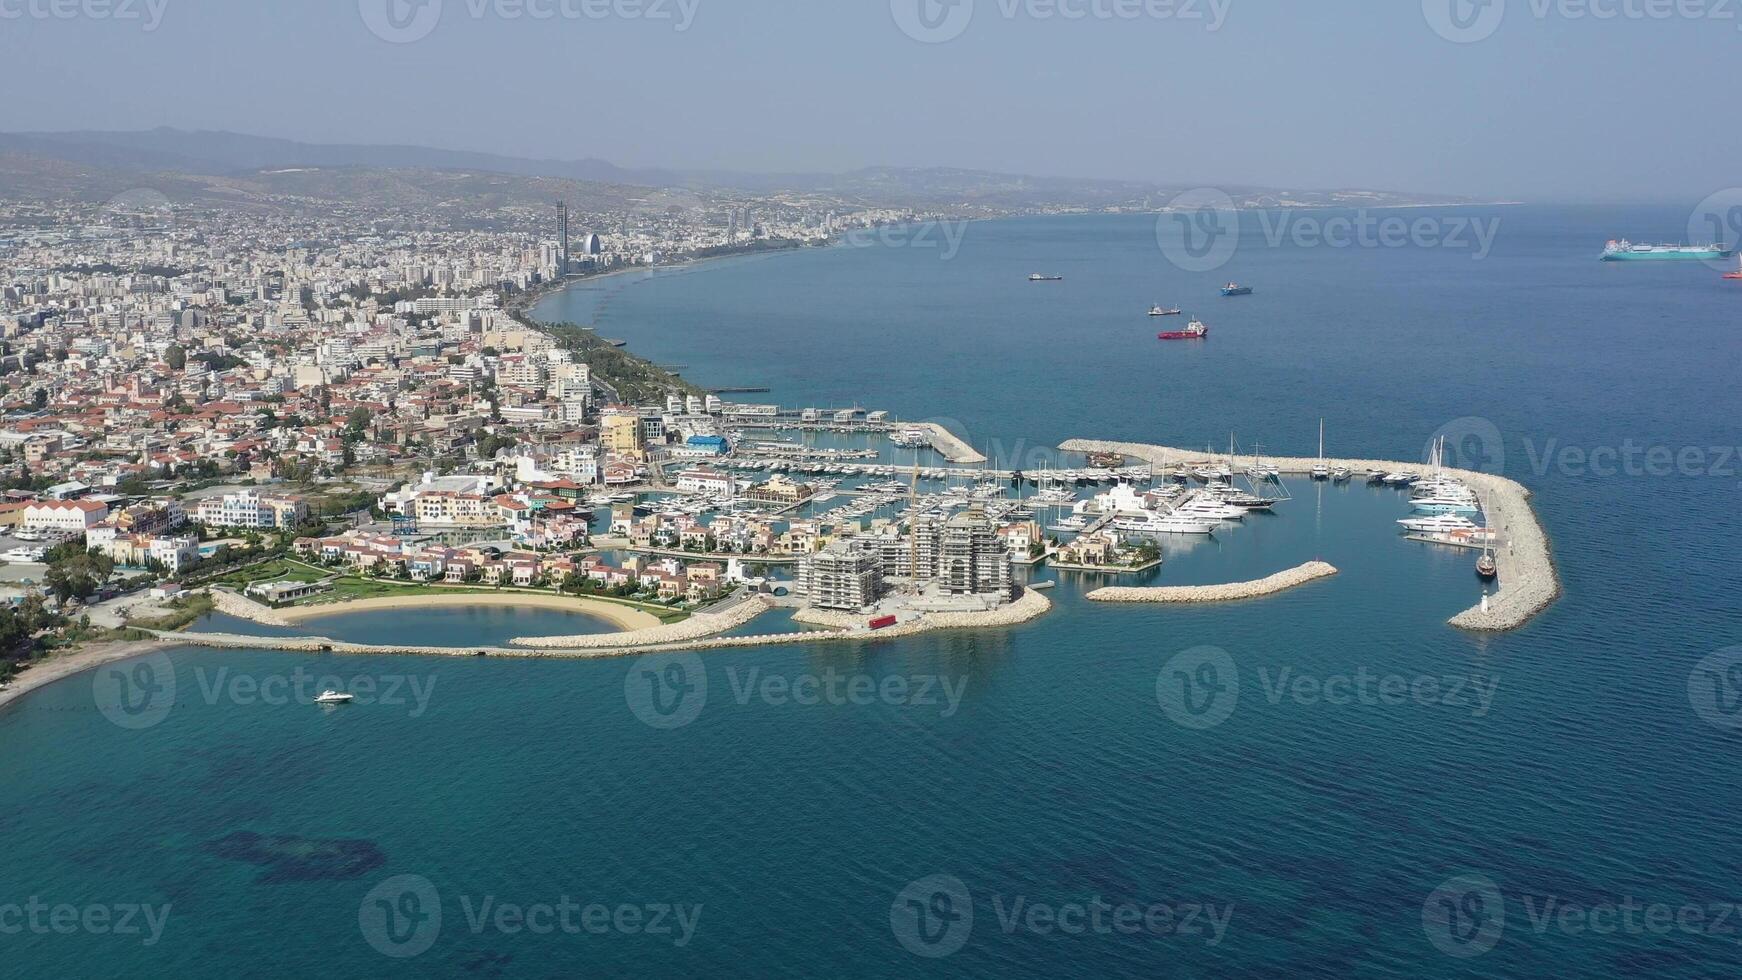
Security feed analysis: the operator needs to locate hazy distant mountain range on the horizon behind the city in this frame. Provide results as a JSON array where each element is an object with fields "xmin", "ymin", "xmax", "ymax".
[{"xmin": 0, "ymin": 129, "xmax": 1498, "ymax": 212}]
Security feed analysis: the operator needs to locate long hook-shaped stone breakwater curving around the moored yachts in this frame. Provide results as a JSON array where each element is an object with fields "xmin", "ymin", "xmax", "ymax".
[{"xmin": 1059, "ymin": 439, "xmax": 1561, "ymax": 632}]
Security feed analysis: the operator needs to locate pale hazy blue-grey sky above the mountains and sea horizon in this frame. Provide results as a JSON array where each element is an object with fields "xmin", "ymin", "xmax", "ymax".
[{"xmin": 0, "ymin": 0, "xmax": 1742, "ymax": 200}]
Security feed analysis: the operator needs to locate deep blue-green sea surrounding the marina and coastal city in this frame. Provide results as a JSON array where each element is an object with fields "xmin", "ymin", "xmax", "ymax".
[{"xmin": 0, "ymin": 207, "xmax": 1742, "ymax": 980}]
